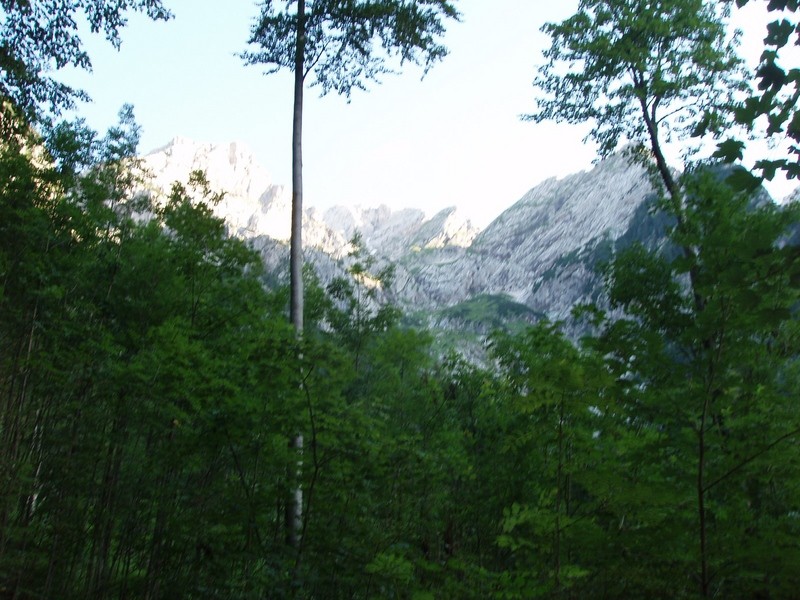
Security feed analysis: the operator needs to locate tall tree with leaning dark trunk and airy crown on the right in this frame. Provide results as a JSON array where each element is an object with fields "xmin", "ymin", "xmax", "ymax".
[{"xmin": 529, "ymin": 0, "xmax": 788, "ymax": 597}]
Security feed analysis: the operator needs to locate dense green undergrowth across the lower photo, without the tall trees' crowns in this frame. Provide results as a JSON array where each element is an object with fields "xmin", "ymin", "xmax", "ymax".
[{"xmin": 0, "ymin": 111, "xmax": 800, "ymax": 598}]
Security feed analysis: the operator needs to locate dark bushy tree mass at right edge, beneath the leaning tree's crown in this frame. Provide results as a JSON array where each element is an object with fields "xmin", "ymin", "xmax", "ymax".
[{"xmin": 588, "ymin": 167, "xmax": 800, "ymax": 597}]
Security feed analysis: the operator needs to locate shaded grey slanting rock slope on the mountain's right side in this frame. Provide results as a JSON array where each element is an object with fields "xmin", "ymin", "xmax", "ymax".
[{"xmin": 390, "ymin": 155, "xmax": 653, "ymax": 319}]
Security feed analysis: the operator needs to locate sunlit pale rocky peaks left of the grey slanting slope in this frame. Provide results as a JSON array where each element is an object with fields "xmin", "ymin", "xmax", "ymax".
[{"xmin": 143, "ymin": 137, "xmax": 479, "ymax": 260}]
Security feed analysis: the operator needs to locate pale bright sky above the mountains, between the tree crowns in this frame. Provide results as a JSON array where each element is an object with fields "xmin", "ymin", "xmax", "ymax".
[{"xmin": 60, "ymin": 0, "xmax": 794, "ymax": 226}]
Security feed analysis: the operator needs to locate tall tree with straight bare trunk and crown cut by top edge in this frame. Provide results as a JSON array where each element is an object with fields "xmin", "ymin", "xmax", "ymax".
[{"xmin": 242, "ymin": 0, "xmax": 458, "ymax": 545}]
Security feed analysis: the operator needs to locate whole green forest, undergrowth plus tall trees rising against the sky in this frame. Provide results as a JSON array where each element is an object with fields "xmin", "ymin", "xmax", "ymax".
[{"xmin": 0, "ymin": 0, "xmax": 800, "ymax": 600}]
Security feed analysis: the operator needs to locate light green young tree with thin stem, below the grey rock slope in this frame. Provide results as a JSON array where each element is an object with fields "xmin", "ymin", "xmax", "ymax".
[{"xmin": 492, "ymin": 322, "xmax": 614, "ymax": 597}]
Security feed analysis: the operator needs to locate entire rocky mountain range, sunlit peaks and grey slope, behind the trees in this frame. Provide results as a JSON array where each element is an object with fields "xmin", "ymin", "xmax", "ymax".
[{"xmin": 139, "ymin": 138, "xmax": 659, "ymax": 329}]
